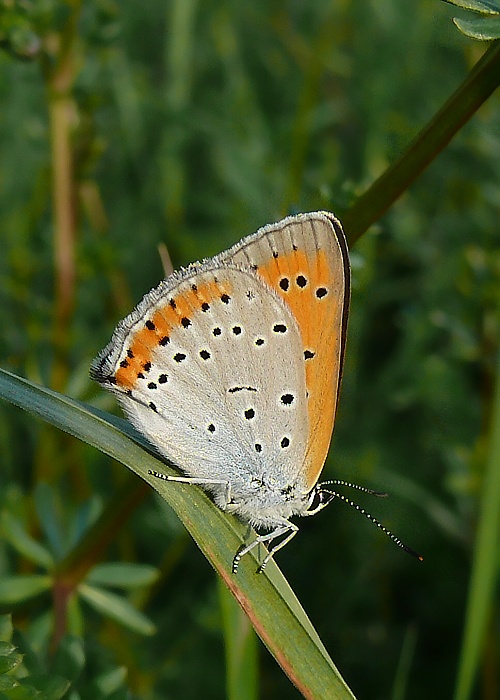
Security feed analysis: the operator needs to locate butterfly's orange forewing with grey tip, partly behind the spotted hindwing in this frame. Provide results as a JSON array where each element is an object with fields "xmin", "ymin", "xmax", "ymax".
[{"xmin": 219, "ymin": 212, "xmax": 350, "ymax": 488}]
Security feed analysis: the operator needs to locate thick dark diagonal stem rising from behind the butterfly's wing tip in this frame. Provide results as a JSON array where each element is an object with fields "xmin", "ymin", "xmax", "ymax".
[{"xmin": 342, "ymin": 41, "xmax": 500, "ymax": 246}]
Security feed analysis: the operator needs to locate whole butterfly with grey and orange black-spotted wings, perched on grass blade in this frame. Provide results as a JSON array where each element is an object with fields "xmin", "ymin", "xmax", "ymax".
[{"xmin": 91, "ymin": 212, "xmax": 349, "ymax": 569}]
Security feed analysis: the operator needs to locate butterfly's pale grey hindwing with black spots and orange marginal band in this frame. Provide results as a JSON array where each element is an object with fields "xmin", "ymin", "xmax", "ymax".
[{"xmin": 91, "ymin": 259, "xmax": 308, "ymax": 503}]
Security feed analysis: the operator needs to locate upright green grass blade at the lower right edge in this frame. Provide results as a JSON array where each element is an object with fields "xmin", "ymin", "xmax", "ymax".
[{"xmin": 455, "ymin": 330, "xmax": 500, "ymax": 700}]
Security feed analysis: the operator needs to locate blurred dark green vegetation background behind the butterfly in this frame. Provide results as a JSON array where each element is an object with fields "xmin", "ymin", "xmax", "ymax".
[{"xmin": 0, "ymin": 0, "xmax": 500, "ymax": 700}]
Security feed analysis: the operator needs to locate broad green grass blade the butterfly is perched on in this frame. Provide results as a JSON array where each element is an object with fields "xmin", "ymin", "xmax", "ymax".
[{"xmin": 0, "ymin": 370, "xmax": 354, "ymax": 700}]
